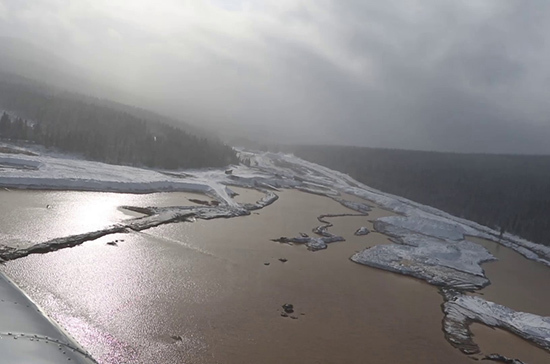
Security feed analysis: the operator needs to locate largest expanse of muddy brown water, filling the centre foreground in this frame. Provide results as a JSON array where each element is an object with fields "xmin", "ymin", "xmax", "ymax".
[{"xmin": 0, "ymin": 191, "xmax": 548, "ymax": 364}]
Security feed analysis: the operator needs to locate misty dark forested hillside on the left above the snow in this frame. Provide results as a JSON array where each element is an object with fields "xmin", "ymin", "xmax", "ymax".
[{"xmin": 0, "ymin": 80, "xmax": 237, "ymax": 169}]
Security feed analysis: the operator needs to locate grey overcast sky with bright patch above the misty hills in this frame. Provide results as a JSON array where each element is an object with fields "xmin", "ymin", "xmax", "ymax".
[{"xmin": 0, "ymin": 0, "xmax": 550, "ymax": 153}]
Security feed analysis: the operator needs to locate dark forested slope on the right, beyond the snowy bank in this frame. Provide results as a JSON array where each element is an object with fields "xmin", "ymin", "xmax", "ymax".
[{"xmin": 290, "ymin": 146, "xmax": 550, "ymax": 245}]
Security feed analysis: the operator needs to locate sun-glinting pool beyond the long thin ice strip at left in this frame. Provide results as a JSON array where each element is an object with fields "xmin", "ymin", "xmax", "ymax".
[{"xmin": 0, "ymin": 190, "xmax": 210, "ymax": 247}]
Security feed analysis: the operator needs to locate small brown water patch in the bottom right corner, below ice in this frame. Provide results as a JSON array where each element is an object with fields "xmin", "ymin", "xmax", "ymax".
[{"xmin": 470, "ymin": 323, "xmax": 550, "ymax": 364}]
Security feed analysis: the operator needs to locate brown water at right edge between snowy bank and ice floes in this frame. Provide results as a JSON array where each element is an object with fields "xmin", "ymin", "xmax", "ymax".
[{"xmin": 467, "ymin": 237, "xmax": 550, "ymax": 316}]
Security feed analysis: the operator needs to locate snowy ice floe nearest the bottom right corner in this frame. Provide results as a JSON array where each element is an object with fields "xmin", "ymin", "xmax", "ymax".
[{"xmin": 442, "ymin": 290, "xmax": 550, "ymax": 354}]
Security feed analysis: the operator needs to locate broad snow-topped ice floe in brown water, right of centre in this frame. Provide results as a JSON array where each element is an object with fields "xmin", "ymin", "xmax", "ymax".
[{"xmin": 351, "ymin": 216, "xmax": 496, "ymax": 290}]
